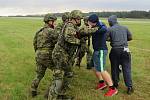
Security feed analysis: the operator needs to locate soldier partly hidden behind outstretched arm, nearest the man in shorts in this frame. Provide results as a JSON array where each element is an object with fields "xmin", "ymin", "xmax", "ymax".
[{"xmin": 76, "ymin": 17, "xmax": 92, "ymax": 69}]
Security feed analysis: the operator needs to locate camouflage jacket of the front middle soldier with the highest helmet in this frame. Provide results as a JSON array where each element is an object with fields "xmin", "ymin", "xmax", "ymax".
[{"xmin": 57, "ymin": 22, "xmax": 80, "ymax": 56}]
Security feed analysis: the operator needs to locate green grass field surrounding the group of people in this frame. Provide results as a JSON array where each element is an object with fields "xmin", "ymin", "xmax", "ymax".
[{"xmin": 0, "ymin": 17, "xmax": 150, "ymax": 100}]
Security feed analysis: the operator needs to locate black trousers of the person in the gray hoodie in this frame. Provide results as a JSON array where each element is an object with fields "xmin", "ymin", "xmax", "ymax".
[{"xmin": 109, "ymin": 48, "xmax": 132, "ymax": 87}]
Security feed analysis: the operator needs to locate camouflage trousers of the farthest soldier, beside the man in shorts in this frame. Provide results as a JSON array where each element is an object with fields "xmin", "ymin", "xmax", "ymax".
[{"xmin": 76, "ymin": 43, "xmax": 92, "ymax": 67}]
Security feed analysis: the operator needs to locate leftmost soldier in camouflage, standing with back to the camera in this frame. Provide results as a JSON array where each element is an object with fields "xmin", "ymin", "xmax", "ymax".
[{"xmin": 31, "ymin": 14, "xmax": 58, "ymax": 97}]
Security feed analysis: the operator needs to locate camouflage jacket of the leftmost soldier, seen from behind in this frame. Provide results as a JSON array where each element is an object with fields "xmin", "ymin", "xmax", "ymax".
[{"xmin": 33, "ymin": 24, "xmax": 59, "ymax": 51}]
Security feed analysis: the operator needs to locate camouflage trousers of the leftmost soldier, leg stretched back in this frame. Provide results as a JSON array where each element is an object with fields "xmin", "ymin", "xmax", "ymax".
[{"xmin": 31, "ymin": 49, "xmax": 54, "ymax": 91}]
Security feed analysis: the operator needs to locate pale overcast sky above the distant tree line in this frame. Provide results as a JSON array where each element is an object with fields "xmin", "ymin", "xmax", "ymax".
[{"xmin": 0, "ymin": 0, "xmax": 150, "ymax": 16}]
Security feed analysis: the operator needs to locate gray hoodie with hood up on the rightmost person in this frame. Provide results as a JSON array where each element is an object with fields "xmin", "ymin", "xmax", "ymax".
[{"xmin": 107, "ymin": 15, "xmax": 132, "ymax": 48}]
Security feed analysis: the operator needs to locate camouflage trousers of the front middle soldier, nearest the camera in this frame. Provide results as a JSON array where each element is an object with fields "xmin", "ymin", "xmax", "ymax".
[{"xmin": 48, "ymin": 45, "xmax": 73, "ymax": 100}]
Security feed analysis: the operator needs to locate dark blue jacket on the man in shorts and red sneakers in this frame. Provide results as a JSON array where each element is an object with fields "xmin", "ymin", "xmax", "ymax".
[{"xmin": 92, "ymin": 21, "xmax": 107, "ymax": 51}]
